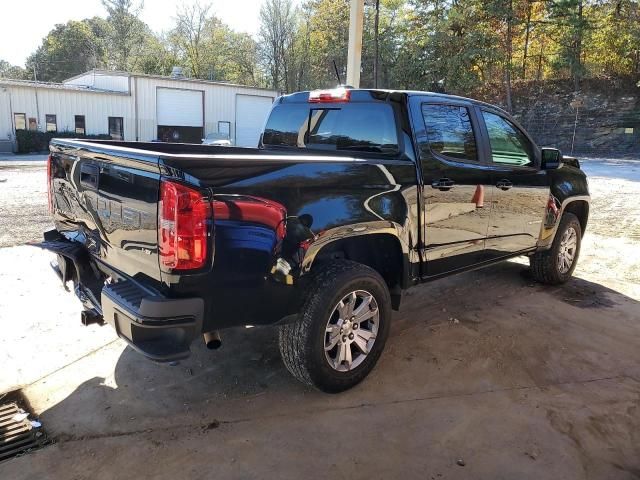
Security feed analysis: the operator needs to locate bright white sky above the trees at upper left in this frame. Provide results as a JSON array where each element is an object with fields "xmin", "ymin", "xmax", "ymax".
[{"xmin": 0, "ymin": 0, "xmax": 263, "ymax": 67}]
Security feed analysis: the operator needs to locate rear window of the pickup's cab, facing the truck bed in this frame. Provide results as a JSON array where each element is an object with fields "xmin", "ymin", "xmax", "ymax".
[{"xmin": 262, "ymin": 103, "xmax": 398, "ymax": 154}]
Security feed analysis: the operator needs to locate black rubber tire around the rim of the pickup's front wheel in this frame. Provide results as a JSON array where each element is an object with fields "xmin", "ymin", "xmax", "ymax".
[{"xmin": 529, "ymin": 212, "xmax": 582, "ymax": 285}]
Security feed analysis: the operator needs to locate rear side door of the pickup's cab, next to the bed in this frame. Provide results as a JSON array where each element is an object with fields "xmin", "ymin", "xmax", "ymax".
[{"xmin": 418, "ymin": 100, "xmax": 492, "ymax": 277}]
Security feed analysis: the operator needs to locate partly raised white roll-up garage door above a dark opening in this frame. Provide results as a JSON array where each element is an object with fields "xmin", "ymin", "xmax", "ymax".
[{"xmin": 156, "ymin": 88, "xmax": 204, "ymax": 127}]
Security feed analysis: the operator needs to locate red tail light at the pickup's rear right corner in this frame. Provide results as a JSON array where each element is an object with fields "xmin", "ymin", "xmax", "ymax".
[{"xmin": 158, "ymin": 180, "xmax": 211, "ymax": 271}]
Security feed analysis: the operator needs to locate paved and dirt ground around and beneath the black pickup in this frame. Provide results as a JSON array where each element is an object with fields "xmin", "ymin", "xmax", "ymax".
[{"xmin": 0, "ymin": 160, "xmax": 640, "ymax": 479}]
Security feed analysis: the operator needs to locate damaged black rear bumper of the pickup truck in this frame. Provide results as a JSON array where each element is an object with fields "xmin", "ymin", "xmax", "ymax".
[{"xmin": 34, "ymin": 232, "xmax": 204, "ymax": 362}]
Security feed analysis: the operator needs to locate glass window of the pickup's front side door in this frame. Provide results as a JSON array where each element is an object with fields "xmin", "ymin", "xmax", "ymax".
[{"xmin": 482, "ymin": 110, "xmax": 534, "ymax": 167}]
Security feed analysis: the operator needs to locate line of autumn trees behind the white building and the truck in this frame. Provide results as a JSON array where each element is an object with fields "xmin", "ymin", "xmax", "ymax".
[{"xmin": 13, "ymin": 0, "xmax": 640, "ymax": 100}]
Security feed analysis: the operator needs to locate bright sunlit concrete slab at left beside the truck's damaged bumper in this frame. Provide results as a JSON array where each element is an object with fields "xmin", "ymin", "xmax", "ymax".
[{"xmin": 0, "ymin": 246, "xmax": 117, "ymax": 393}]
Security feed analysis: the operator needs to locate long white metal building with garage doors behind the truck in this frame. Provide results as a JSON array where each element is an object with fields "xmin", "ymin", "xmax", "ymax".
[{"xmin": 0, "ymin": 70, "xmax": 277, "ymax": 151}]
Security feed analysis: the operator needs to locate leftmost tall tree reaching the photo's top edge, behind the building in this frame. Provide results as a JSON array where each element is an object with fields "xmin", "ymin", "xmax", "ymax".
[{"xmin": 102, "ymin": 0, "xmax": 149, "ymax": 71}]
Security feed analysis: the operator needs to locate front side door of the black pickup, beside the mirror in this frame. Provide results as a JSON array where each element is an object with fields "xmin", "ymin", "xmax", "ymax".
[{"xmin": 478, "ymin": 107, "xmax": 549, "ymax": 259}]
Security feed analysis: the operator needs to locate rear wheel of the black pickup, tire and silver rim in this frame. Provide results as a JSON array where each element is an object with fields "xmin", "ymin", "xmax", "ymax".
[{"xmin": 280, "ymin": 261, "xmax": 391, "ymax": 393}]
